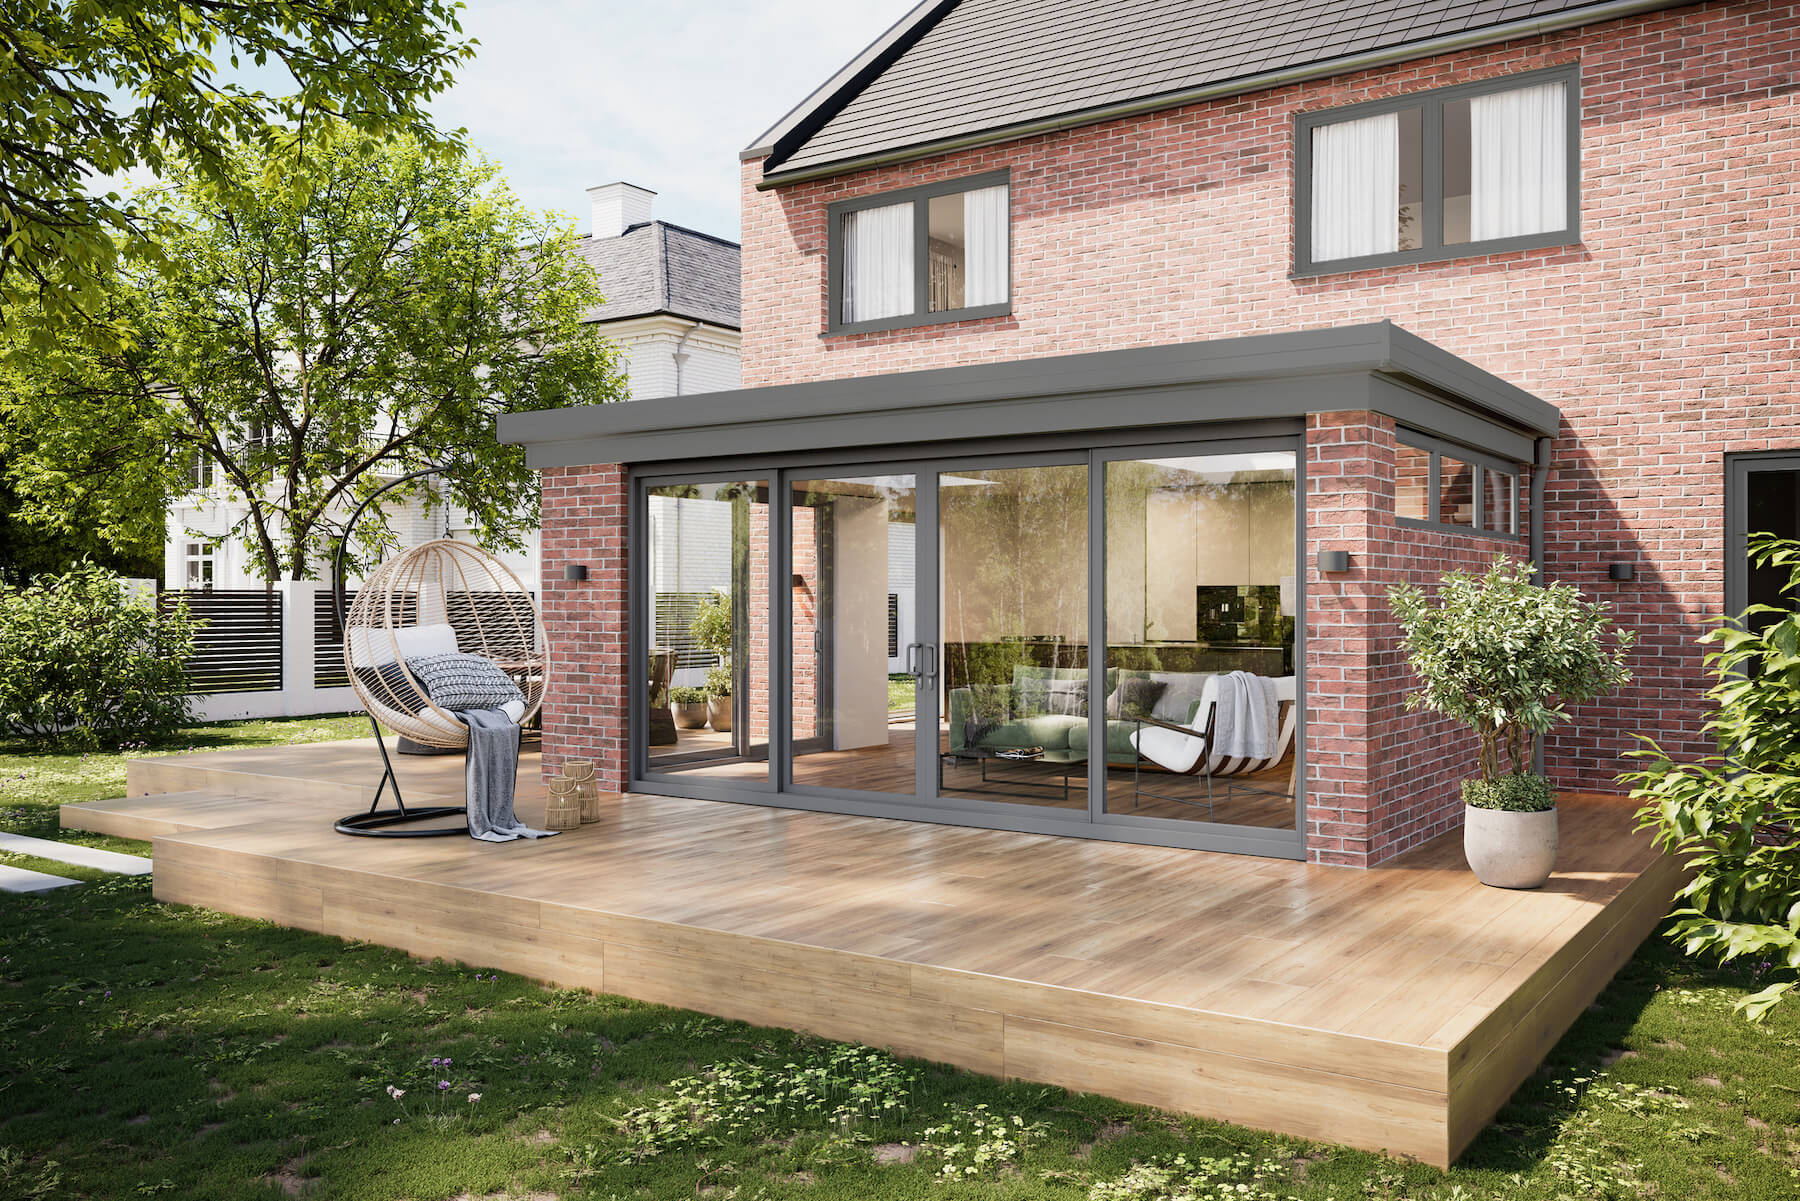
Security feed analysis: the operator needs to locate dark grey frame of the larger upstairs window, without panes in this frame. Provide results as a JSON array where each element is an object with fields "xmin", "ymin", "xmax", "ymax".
[{"xmin": 1292, "ymin": 65, "xmax": 1580, "ymax": 279}]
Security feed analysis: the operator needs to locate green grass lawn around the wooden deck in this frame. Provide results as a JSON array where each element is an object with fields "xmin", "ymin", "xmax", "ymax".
[{"xmin": 0, "ymin": 724, "xmax": 1800, "ymax": 1201}]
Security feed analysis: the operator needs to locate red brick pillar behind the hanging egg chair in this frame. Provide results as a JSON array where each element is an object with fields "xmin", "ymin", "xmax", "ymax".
[{"xmin": 540, "ymin": 463, "xmax": 630, "ymax": 790}]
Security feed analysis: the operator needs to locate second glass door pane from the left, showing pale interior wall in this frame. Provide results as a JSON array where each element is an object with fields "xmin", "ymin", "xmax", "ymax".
[{"xmin": 788, "ymin": 474, "xmax": 925, "ymax": 796}]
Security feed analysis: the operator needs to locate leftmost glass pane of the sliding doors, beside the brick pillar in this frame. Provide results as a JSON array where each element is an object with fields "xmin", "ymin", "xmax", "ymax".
[{"xmin": 637, "ymin": 479, "xmax": 770, "ymax": 787}]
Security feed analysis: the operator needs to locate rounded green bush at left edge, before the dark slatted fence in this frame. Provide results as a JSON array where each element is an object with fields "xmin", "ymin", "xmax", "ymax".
[{"xmin": 0, "ymin": 564, "xmax": 196, "ymax": 747}]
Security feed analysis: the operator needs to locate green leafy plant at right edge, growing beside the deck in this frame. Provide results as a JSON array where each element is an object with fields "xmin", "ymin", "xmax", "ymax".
[{"xmin": 1620, "ymin": 535, "xmax": 1800, "ymax": 1021}]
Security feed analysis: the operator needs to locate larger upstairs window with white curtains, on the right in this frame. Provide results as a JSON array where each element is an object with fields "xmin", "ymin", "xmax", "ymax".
[{"xmin": 1294, "ymin": 68, "xmax": 1580, "ymax": 275}]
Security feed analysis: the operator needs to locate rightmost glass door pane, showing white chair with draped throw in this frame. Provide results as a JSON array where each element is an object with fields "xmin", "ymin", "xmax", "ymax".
[{"xmin": 1103, "ymin": 452, "xmax": 1298, "ymax": 830}]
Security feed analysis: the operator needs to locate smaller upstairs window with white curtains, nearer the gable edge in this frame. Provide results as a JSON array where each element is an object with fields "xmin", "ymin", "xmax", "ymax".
[{"xmin": 830, "ymin": 173, "xmax": 1012, "ymax": 333}]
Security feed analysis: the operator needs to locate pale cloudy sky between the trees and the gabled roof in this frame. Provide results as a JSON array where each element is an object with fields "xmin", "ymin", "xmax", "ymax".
[{"xmin": 432, "ymin": 0, "xmax": 914, "ymax": 239}]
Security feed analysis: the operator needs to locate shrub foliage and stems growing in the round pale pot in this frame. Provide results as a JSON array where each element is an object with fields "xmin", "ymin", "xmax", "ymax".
[{"xmin": 1388, "ymin": 555, "xmax": 1634, "ymax": 808}]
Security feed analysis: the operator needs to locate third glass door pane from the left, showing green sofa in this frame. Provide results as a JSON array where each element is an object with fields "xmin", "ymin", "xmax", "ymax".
[{"xmin": 936, "ymin": 459, "xmax": 1089, "ymax": 814}]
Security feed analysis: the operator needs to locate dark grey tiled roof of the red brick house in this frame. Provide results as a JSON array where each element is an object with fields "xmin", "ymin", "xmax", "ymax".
[{"xmin": 745, "ymin": 0, "xmax": 1681, "ymax": 184}]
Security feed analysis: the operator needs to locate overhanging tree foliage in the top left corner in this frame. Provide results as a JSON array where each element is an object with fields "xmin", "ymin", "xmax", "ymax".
[{"xmin": 0, "ymin": 0, "xmax": 473, "ymax": 339}]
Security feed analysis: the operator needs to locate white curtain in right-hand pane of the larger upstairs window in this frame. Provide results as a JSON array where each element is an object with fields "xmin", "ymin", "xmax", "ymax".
[{"xmin": 1469, "ymin": 83, "xmax": 1568, "ymax": 241}]
